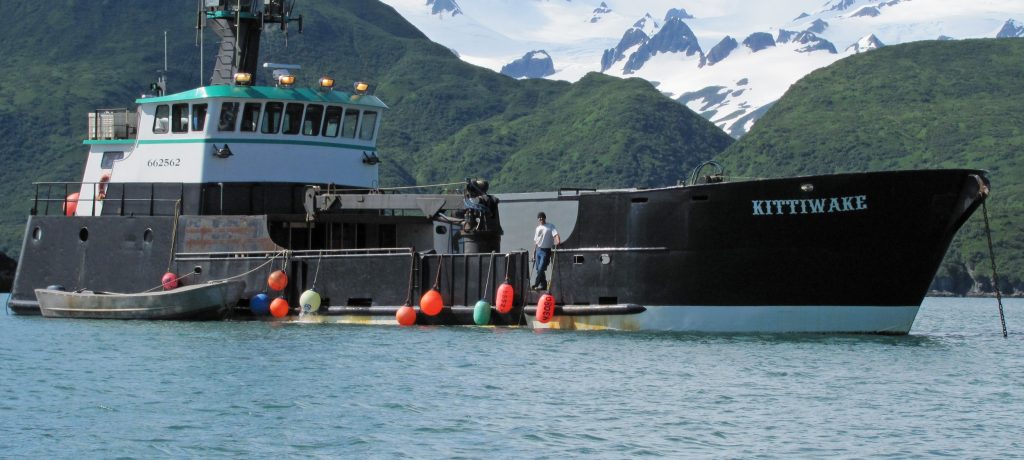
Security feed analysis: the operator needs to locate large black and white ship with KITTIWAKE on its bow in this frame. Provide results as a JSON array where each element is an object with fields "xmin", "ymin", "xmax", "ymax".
[{"xmin": 8, "ymin": 0, "xmax": 990, "ymax": 334}]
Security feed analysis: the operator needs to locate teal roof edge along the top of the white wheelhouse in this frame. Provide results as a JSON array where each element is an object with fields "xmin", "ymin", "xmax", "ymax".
[{"xmin": 135, "ymin": 85, "xmax": 388, "ymax": 109}]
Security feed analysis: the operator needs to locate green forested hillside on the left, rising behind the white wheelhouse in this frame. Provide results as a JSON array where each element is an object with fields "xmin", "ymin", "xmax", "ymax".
[{"xmin": 0, "ymin": 0, "xmax": 732, "ymax": 254}]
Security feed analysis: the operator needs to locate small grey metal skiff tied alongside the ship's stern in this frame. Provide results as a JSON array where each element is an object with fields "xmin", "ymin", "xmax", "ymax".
[{"xmin": 36, "ymin": 281, "xmax": 246, "ymax": 320}]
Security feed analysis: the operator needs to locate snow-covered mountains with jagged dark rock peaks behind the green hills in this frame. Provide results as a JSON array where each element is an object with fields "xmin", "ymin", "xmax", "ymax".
[{"xmin": 384, "ymin": 0, "xmax": 1024, "ymax": 137}]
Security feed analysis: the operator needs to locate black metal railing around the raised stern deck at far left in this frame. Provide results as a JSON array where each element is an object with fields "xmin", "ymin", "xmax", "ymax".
[{"xmin": 30, "ymin": 181, "xmax": 184, "ymax": 216}]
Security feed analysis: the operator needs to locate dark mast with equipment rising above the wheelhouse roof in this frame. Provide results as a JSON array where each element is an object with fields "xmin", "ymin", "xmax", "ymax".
[{"xmin": 200, "ymin": 0, "xmax": 302, "ymax": 85}]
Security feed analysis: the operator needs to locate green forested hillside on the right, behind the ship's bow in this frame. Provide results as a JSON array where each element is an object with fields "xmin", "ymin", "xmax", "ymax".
[{"xmin": 720, "ymin": 39, "xmax": 1024, "ymax": 293}]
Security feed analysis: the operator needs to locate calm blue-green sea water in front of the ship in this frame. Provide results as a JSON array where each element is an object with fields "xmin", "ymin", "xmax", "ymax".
[{"xmin": 0, "ymin": 298, "xmax": 1024, "ymax": 458}]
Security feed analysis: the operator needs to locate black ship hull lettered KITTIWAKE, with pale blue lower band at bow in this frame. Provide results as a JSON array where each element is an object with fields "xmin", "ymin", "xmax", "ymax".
[{"xmin": 10, "ymin": 170, "xmax": 988, "ymax": 334}]
